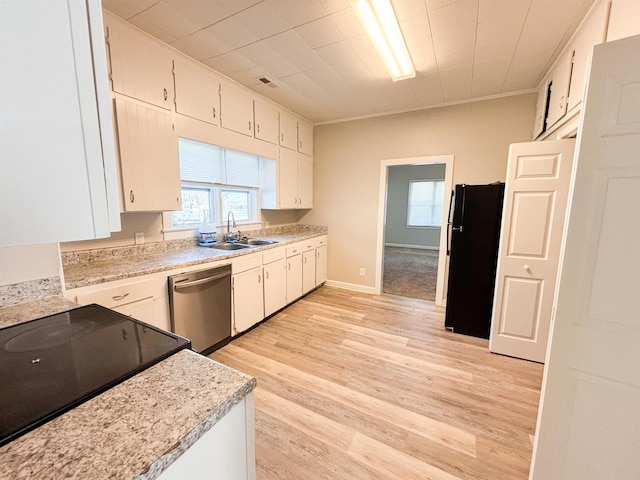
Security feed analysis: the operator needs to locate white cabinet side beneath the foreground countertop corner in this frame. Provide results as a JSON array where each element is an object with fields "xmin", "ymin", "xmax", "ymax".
[{"xmin": 157, "ymin": 393, "xmax": 256, "ymax": 480}]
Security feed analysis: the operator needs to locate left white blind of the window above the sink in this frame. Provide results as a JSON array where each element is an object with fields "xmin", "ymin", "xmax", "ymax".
[{"xmin": 178, "ymin": 138, "xmax": 226, "ymax": 183}]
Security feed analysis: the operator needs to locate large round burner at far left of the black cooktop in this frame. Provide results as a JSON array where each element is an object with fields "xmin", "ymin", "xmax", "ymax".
[{"xmin": 4, "ymin": 319, "xmax": 96, "ymax": 353}]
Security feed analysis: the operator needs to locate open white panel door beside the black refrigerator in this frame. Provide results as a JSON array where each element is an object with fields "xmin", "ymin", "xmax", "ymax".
[{"xmin": 489, "ymin": 140, "xmax": 575, "ymax": 362}]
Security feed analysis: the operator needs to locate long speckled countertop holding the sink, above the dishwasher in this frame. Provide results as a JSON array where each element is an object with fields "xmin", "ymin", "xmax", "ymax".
[{"xmin": 63, "ymin": 227, "xmax": 327, "ymax": 289}]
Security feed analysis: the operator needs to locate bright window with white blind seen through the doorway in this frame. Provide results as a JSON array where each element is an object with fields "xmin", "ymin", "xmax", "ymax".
[{"xmin": 407, "ymin": 180, "xmax": 444, "ymax": 227}]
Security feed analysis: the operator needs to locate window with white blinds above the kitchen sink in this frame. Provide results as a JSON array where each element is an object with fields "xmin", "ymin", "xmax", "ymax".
[{"xmin": 171, "ymin": 138, "xmax": 260, "ymax": 228}]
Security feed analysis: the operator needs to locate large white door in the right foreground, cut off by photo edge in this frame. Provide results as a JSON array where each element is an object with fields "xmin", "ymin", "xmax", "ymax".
[{"xmin": 530, "ymin": 36, "xmax": 640, "ymax": 480}]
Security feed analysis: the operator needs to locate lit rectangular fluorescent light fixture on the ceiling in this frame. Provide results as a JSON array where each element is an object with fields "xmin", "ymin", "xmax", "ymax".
[{"xmin": 351, "ymin": 0, "xmax": 416, "ymax": 82}]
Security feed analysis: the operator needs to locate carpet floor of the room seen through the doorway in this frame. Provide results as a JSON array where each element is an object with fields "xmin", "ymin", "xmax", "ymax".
[{"xmin": 382, "ymin": 247, "xmax": 438, "ymax": 301}]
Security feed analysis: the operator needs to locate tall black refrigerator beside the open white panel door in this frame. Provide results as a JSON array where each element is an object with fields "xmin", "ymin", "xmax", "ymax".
[{"xmin": 444, "ymin": 183, "xmax": 504, "ymax": 338}]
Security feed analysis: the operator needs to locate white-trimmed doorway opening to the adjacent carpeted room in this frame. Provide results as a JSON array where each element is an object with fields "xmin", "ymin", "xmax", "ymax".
[{"xmin": 375, "ymin": 155, "xmax": 453, "ymax": 305}]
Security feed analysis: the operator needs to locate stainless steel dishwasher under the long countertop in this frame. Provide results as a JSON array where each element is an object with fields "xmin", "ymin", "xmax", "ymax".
[{"xmin": 169, "ymin": 265, "xmax": 231, "ymax": 355}]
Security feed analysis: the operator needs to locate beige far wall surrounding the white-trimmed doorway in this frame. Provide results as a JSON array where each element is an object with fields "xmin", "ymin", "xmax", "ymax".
[{"xmin": 301, "ymin": 93, "xmax": 536, "ymax": 288}]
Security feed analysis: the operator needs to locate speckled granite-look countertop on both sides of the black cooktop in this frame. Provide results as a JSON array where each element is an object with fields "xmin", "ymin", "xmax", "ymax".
[{"xmin": 0, "ymin": 297, "xmax": 256, "ymax": 480}]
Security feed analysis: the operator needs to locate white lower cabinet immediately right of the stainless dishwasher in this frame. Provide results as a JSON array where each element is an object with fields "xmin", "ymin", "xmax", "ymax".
[{"xmin": 231, "ymin": 255, "xmax": 264, "ymax": 335}]
